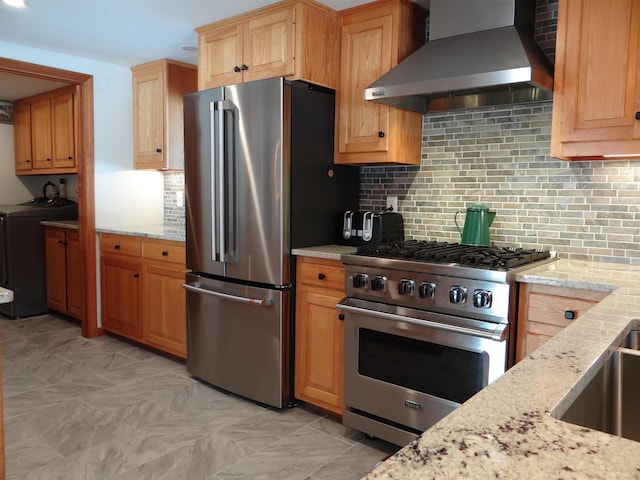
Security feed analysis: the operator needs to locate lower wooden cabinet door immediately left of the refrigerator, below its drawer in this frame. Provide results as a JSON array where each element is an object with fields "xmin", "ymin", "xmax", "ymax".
[{"xmin": 142, "ymin": 264, "xmax": 187, "ymax": 358}]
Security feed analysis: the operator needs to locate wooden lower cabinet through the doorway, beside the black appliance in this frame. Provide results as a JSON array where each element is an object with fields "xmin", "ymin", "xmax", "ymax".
[{"xmin": 44, "ymin": 227, "xmax": 84, "ymax": 319}]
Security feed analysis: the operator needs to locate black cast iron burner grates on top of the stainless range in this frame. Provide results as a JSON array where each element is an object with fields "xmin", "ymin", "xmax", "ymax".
[{"xmin": 356, "ymin": 240, "xmax": 550, "ymax": 270}]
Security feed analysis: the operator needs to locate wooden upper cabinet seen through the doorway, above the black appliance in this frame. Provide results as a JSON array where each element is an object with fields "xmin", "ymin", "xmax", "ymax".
[{"xmin": 14, "ymin": 86, "xmax": 78, "ymax": 175}]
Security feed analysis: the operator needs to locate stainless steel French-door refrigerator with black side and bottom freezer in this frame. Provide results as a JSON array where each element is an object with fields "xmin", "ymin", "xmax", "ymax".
[{"xmin": 184, "ymin": 78, "xmax": 359, "ymax": 408}]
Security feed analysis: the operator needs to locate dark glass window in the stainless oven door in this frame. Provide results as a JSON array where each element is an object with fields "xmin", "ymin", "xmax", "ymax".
[{"xmin": 358, "ymin": 328, "xmax": 489, "ymax": 403}]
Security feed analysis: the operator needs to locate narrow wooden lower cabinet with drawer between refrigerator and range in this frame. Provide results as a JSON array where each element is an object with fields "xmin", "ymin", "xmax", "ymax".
[{"xmin": 294, "ymin": 257, "xmax": 345, "ymax": 415}]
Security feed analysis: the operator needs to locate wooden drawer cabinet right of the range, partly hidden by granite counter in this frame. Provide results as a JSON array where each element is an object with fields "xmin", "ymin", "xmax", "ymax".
[{"xmin": 516, "ymin": 283, "xmax": 609, "ymax": 362}]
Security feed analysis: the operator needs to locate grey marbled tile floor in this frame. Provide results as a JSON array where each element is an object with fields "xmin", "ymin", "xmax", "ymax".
[{"xmin": 0, "ymin": 315, "xmax": 397, "ymax": 480}]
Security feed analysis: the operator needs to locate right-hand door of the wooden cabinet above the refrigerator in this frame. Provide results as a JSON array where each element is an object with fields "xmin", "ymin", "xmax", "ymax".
[{"xmin": 242, "ymin": 8, "xmax": 295, "ymax": 82}]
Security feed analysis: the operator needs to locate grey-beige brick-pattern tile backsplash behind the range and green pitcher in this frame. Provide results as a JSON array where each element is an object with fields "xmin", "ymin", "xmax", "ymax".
[{"xmin": 360, "ymin": 102, "xmax": 640, "ymax": 265}]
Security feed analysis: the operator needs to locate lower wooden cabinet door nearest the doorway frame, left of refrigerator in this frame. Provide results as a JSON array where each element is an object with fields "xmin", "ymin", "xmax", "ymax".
[{"xmin": 100, "ymin": 255, "xmax": 142, "ymax": 340}]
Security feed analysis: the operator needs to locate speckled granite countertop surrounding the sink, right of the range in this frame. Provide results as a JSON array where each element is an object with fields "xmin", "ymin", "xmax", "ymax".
[{"xmin": 364, "ymin": 259, "xmax": 640, "ymax": 480}]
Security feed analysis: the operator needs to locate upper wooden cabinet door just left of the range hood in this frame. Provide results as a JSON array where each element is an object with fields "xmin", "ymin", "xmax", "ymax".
[{"xmin": 338, "ymin": 15, "xmax": 392, "ymax": 153}]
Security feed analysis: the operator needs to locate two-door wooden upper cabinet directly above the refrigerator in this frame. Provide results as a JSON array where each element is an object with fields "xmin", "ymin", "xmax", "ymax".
[{"xmin": 196, "ymin": 0, "xmax": 339, "ymax": 90}]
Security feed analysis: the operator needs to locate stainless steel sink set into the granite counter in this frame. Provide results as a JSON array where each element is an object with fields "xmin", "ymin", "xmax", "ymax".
[{"xmin": 551, "ymin": 327, "xmax": 640, "ymax": 441}]
